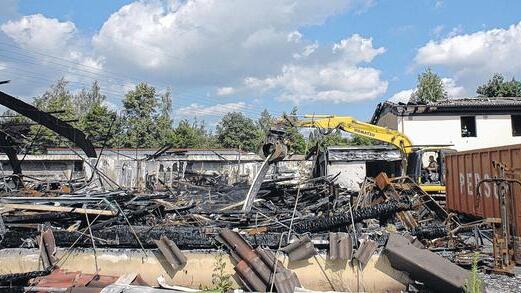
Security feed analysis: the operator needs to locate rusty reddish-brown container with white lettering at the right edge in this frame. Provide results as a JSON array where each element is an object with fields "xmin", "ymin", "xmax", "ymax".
[{"xmin": 445, "ymin": 144, "xmax": 521, "ymax": 235}]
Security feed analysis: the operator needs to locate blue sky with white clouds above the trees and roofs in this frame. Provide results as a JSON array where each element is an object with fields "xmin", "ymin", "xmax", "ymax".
[{"xmin": 0, "ymin": 0, "xmax": 521, "ymax": 124}]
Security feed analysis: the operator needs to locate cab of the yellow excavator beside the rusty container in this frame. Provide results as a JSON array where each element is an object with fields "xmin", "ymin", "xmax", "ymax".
[{"xmin": 406, "ymin": 147, "xmax": 455, "ymax": 193}]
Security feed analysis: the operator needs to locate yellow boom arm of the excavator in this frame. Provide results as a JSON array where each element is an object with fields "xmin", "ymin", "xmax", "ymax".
[{"xmin": 296, "ymin": 115, "xmax": 412, "ymax": 155}]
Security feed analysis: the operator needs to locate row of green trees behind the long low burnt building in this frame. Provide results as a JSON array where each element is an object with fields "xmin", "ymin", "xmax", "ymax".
[{"xmin": 2, "ymin": 78, "xmax": 371, "ymax": 154}]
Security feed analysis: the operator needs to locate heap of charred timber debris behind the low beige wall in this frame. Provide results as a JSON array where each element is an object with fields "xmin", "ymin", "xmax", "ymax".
[{"xmin": 0, "ymin": 171, "xmax": 458, "ymax": 249}]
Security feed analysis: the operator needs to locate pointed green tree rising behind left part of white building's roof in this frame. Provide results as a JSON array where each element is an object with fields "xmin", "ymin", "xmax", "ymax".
[{"xmin": 411, "ymin": 68, "xmax": 447, "ymax": 103}]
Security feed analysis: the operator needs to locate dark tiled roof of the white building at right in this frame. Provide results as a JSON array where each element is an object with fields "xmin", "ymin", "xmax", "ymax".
[{"xmin": 371, "ymin": 97, "xmax": 521, "ymax": 124}]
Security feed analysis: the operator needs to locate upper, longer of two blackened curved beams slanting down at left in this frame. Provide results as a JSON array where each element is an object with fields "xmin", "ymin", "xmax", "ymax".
[{"xmin": 0, "ymin": 91, "xmax": 96, "ymax": 158}]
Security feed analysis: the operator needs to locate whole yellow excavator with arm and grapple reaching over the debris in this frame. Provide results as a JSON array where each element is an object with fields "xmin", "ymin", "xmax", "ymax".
[{"xmin": 263, "ymin": 115, "xmax": 455, "ymax": 193}]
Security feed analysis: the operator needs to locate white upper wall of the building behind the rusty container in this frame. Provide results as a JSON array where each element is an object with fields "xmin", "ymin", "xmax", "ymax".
[{"xmin": 398, "ymin": 115, "xmax": 521, "ymax": 151}]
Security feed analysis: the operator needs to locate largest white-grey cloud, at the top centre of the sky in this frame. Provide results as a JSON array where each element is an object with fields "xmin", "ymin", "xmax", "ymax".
[{"xmin": 93, "ymin": 0, "xmax": 374, "ymax": 85}]
